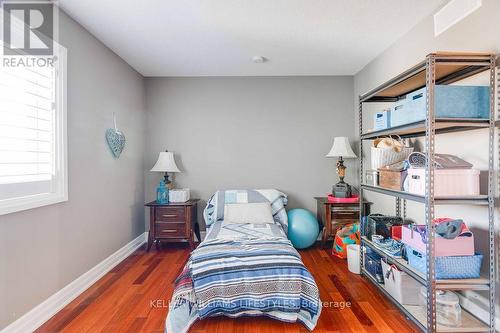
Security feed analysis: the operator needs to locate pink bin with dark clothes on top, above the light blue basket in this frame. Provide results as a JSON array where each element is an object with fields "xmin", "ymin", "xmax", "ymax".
[{"xmin": 401, "ymin": 225, "xmax": 474, "ymax": 257}]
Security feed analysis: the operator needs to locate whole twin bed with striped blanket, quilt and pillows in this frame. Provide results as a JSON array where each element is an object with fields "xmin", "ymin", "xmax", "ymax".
[{"xmin": 165, "ymin": 190, "xmax": 321, "ymax": 333}]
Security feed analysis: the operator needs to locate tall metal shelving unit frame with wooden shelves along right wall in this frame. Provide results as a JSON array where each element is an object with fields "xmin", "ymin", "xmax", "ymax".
[{"xmin": 359, "ymin": 53, "xmax": 500, "ymax": 332}]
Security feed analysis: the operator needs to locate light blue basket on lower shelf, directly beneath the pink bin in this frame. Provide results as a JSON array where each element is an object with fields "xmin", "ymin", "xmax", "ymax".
[{"xmin": 406, "ymin": 246, "xmax": 483, "ymax": 279}]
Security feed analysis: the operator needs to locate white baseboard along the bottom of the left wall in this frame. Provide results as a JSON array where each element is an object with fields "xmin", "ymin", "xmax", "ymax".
[{"xmin": 2, "ymin": 232, "xmax": 147, "ymax": 333}]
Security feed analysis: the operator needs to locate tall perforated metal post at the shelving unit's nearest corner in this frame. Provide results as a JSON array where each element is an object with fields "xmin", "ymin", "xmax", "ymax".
[{"xmin": 425, "ymin": 54, "xmax": 436, "ymax": 333}]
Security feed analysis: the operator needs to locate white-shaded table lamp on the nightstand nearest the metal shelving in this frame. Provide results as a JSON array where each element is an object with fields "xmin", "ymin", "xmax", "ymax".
[{"xmin": 326, "ymin": 136, "xmax": 357, "ymax": 198}]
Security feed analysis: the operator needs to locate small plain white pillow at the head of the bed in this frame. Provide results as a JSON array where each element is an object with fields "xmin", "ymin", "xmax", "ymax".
[{"xmin": 224, "ymin": 202, "xmax": 274, "ymax": 224}]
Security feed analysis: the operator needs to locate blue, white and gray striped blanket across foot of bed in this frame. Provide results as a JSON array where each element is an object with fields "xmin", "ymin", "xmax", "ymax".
[{"xmin": 191, "ymin": 239, "xmax": 319, "ymax": 319}]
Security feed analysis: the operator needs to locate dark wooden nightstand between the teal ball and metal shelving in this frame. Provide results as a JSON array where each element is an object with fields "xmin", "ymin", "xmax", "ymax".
[{"xmin": 314, "ymin": 197, "xmax": 371, "ymax": 246}]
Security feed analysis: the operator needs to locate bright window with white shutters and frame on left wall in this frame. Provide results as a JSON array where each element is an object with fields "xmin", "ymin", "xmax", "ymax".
[{"xmin": 0, "ymin": 46, "xmax": 68, "ymax": 215}]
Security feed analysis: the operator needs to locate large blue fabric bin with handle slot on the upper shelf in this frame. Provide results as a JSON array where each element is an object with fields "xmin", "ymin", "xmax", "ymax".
[{"xmin": 406, "ymin": 85, "xmax": 490, "ymax": 121}]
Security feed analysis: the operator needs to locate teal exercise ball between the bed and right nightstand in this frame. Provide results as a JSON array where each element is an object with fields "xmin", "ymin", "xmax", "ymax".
[{"xmin": 288, "ymin": 208, "xmax": 319, "ymax": 249}]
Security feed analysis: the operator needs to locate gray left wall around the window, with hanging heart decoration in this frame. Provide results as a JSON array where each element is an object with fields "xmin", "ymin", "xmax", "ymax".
[{"xmin": 0, "ymin": 14, "xmax": 145, "ymax": 330}]
